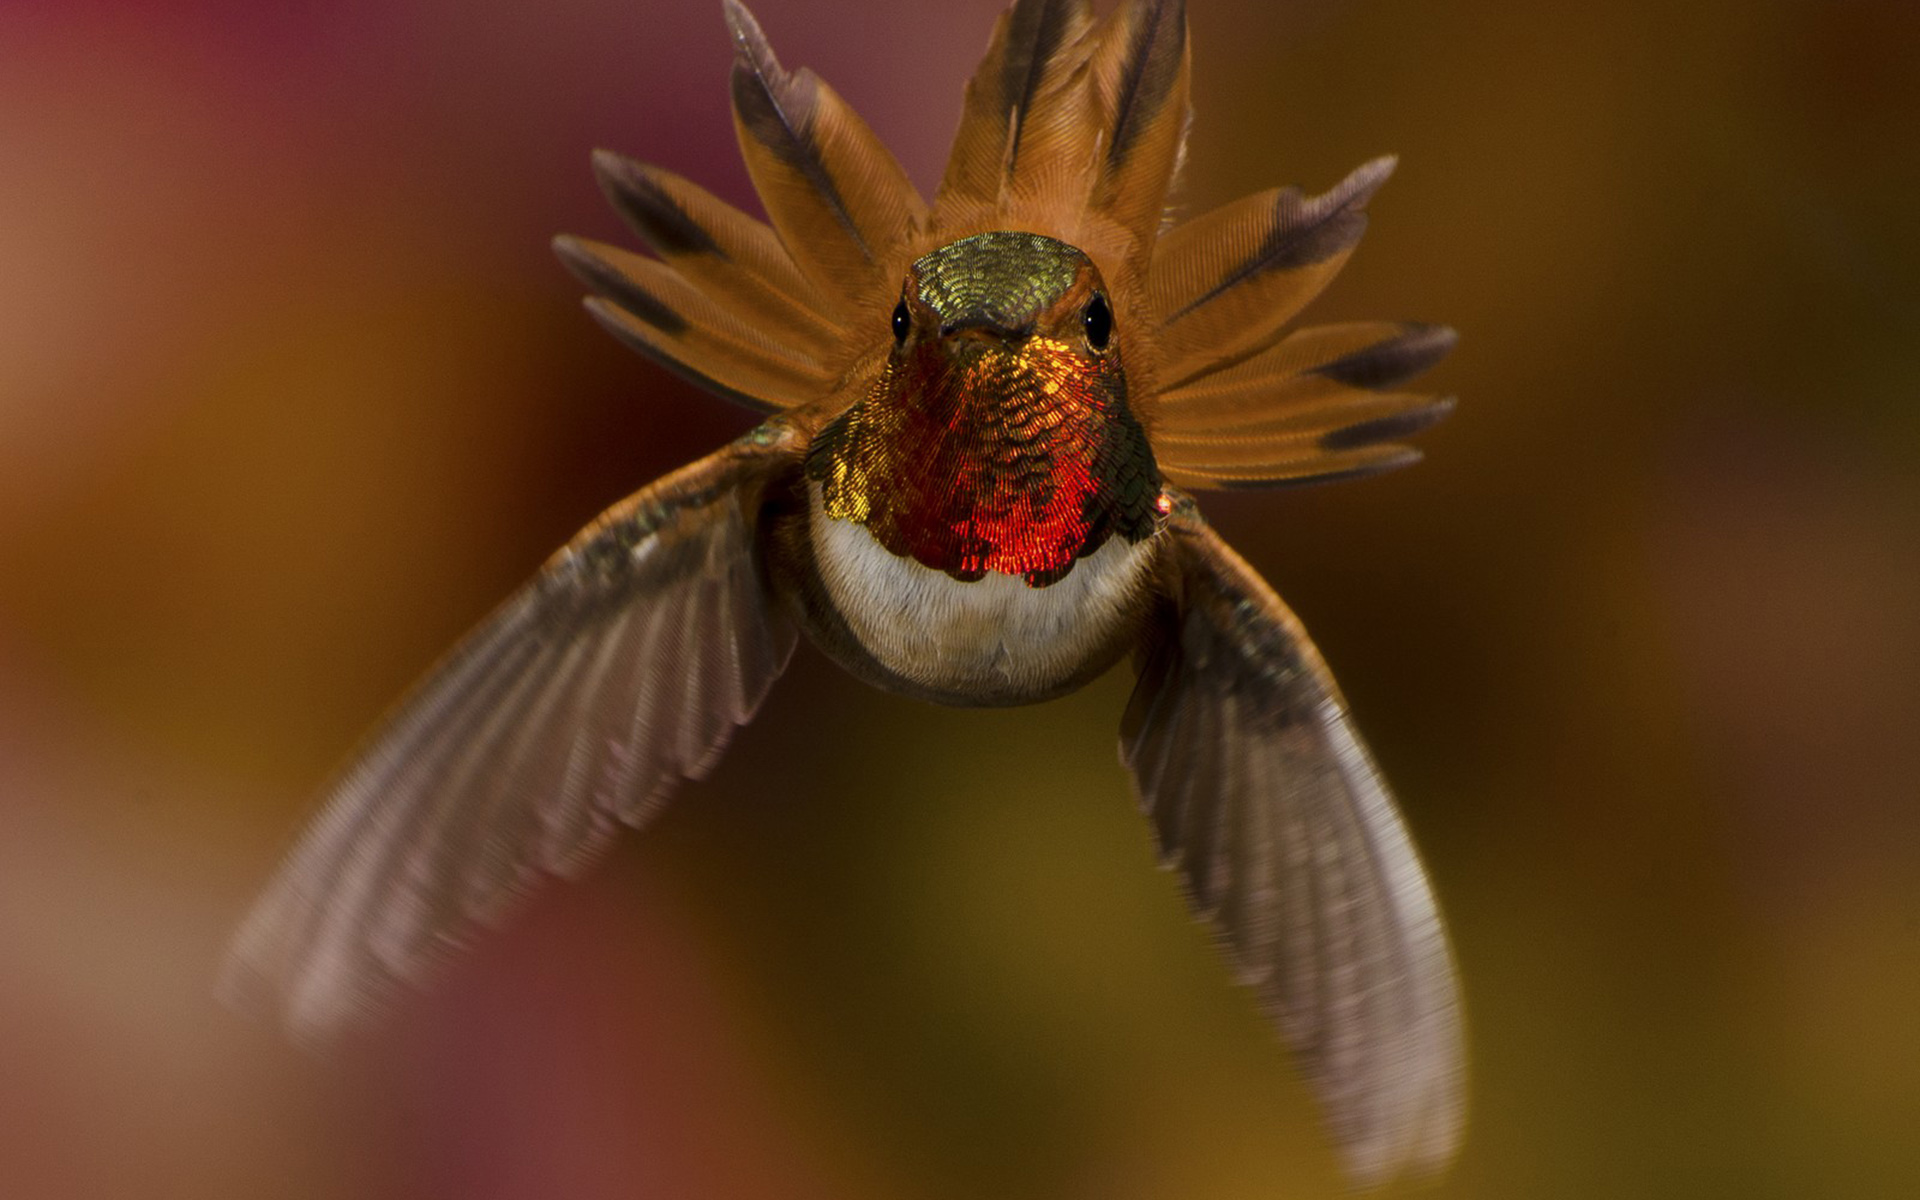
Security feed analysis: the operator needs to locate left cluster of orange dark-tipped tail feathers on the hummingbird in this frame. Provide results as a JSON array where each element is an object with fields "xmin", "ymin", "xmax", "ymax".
[{"xmin": 555, "ymin": 0, "xmax": 927, "ymax": 411}]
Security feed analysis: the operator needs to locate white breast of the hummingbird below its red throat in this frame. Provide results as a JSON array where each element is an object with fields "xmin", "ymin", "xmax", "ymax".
[{"xmin": 810, "ymin": 484, "xmax": 1152, "ymax": 695}]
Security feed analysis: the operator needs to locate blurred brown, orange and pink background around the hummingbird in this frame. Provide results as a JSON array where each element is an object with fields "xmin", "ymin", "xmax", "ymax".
[{"xmin": 0, "ymin": 0, "xmax": 1920, "ymax": 1200}]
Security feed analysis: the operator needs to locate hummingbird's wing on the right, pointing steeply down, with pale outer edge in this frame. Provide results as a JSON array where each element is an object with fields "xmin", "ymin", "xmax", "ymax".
[{"xmin": 1121, "ymin": 501, "xmax": 1465, "ymax": 1183}]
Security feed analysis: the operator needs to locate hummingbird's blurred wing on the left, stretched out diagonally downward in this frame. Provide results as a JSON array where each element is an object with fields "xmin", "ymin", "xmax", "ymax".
[{"xmin": 223, "ymin": 424, "xmax": 804, "ymax": 1039}]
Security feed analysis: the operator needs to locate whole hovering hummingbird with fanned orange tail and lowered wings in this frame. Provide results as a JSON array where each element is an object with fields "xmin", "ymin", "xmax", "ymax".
[{"xmin": 225, "ymin": 0, "xmax": 1465, "ymax": 1183}]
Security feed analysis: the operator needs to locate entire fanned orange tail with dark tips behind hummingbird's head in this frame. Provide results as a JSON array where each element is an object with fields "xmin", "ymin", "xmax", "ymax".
[{"xmin": 555, "ymin": 0, "xmax": 1453, "ymax": 488}]
